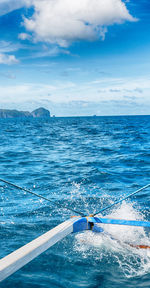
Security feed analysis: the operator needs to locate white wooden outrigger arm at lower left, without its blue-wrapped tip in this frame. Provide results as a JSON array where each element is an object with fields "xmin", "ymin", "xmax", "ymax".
[{"xmin": 0, "ymin": 217, "xmax": 78, "ymax": 282}]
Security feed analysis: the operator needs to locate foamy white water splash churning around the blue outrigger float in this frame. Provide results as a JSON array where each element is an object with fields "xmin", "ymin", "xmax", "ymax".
[{"xmin": 75, "ymin": 201, "xmax": 150, "ymax": 278}]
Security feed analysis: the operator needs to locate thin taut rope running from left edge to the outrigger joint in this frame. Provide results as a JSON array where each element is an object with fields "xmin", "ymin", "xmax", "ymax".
[{"xmin": 0, "ymin": 179, "xmax": 84, "ymax": 216}]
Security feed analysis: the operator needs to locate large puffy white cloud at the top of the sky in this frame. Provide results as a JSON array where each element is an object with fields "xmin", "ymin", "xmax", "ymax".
[{"xmin": 24, "ymin": 0, "xmax": 136, "ymax": 47}]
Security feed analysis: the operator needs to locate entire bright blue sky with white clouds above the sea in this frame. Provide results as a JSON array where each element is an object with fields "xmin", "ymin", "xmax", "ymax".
[{"xmin": 0, "ymin": 0, "xmax": 150, "ymax": 116}]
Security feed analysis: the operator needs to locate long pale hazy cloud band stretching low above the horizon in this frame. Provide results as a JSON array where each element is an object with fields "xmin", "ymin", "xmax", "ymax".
[{"xmin": 0, "ymin": 77, "xmax": 150, "ymax": 107}]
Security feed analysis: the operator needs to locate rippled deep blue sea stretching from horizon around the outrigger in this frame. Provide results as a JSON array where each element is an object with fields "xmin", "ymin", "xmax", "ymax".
[{"xmin": 0, "ymin": 116, "xmax": 150, "ymax": 288}]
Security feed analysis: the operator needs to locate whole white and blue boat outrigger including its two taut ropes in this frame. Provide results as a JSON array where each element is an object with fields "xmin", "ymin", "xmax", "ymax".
[{"xmin": 0, "ymin": 179, "xmax": 150, "ymax": 281}]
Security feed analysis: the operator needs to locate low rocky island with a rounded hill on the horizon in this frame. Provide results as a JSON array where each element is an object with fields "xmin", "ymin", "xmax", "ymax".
[{"xmin": 0, "ymin": 107, "xmax": 50, "ymax": 118}]
